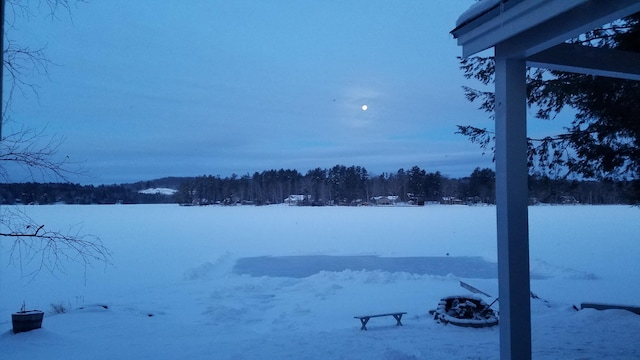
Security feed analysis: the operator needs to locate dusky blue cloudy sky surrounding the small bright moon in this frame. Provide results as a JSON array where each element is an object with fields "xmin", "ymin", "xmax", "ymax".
[{"xmin": 8, "ymin": 0, "xmax": 504, "ymax": 183}]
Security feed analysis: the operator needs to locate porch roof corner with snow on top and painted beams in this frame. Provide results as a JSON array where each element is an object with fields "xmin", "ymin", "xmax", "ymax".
[{"xmin": 451, "ymin": 0, "xmax": 640, "ymax": 80}]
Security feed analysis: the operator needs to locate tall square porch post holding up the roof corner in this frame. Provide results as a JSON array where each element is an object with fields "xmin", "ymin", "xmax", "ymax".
[{"xmin": 495, "ymin": 44, "xmax": 531, "ymax": 360}]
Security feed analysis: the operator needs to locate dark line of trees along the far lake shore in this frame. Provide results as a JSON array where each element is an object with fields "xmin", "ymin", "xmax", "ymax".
[{"xmin": 0, "ymin": 165, "xmax": 631, "ymax": 205}]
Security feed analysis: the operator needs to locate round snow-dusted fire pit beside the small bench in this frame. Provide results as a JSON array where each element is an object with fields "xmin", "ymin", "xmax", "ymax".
[{"xmin": 433, "ymin": 296, "xmax": 498, "ymax": 328}]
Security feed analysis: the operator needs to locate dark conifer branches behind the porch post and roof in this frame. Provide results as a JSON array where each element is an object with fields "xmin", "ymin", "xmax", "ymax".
[{"xmin": 457, "ymin": 14, "xmax": 640, "ymax": 200}]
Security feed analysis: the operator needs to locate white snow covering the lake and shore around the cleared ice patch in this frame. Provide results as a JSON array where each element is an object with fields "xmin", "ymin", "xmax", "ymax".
[{"xmin": 0, "ymin": 205, "xmax": 640, "ymax": 359}]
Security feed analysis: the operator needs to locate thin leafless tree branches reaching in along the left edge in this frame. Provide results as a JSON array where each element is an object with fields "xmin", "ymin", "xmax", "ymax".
[{"xmin": 0, "ymin": 0, "xmax": 111, "ymax": 279}]
